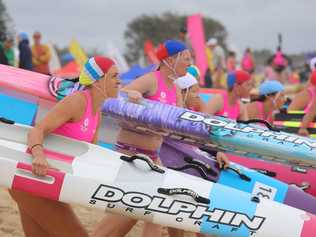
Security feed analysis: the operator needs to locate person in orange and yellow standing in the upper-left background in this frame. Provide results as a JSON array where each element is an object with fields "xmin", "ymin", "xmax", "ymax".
[{"xmin": 32, "ymin": 31, "xmax": 51, "ymax": 74}]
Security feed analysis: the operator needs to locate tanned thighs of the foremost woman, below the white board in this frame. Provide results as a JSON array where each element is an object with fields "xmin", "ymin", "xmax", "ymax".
[{"xmin": 9, "ymin": 190, "xmax": 88, "ymax": 237}]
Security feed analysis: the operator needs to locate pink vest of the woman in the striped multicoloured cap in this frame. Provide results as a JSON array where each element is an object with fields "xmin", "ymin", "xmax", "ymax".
[{"xmin": 54, "ymin": 90, "xmax": 100, "ymax": 142}]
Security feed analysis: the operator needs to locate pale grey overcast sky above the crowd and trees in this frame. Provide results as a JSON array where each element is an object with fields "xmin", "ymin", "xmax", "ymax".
[{"xmin": 4, "ymin": 0, "xmax": 316, "ymax": 53}]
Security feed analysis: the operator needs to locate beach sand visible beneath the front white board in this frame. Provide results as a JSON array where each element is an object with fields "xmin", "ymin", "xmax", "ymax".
[{"xmin": 0, "ymin": 188, "xmax": 195, "ymax": 237}]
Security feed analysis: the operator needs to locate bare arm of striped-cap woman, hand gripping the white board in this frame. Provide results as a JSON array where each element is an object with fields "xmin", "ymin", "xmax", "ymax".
[{"xmin": 28, "ymin": 94, "xmax": 85, "ymax": 175}]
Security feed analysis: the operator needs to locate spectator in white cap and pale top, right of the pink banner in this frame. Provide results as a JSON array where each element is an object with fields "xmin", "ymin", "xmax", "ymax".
[{"xmin": 206, "ymin": 38, "xmax": 226, "ymax": 88}]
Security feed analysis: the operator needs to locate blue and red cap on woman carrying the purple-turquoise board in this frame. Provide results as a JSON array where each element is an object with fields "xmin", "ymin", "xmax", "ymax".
[{"xmin": 157, "ymin": 40, "xmax": 187, "ymax": 61}]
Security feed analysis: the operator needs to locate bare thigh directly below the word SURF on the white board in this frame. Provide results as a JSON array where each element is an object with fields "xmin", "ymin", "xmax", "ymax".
[{"xmin": 92, "ymin": 214, "xmax": 137, "ymax": 237}]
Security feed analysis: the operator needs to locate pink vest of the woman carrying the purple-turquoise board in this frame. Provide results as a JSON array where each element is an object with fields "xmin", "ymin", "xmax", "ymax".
[{"xmin": 146, "ymin": 71, "xmax": 177, "ymax": 106}]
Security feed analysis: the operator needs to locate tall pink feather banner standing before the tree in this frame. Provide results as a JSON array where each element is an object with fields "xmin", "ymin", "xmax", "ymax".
[{"xmin": 187, "ymin": 14, "xmax": 207, "ymax": 85}]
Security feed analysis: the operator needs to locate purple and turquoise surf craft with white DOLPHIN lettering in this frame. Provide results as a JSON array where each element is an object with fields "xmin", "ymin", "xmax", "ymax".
[{"xmin": 103, "ymin": 98, "xmax": 316, "ymax": 167}]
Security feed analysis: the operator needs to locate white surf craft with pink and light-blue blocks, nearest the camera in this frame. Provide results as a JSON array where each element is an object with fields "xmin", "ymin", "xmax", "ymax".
[{"xmin": 0, "ymin": 120, "xmax": 316, "ymax": 237}]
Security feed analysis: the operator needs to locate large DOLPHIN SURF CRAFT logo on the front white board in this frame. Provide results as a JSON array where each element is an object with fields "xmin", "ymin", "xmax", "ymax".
[{"xmin": 90, "ymin": 184, "xmax": 266, "ymax": 233}]
